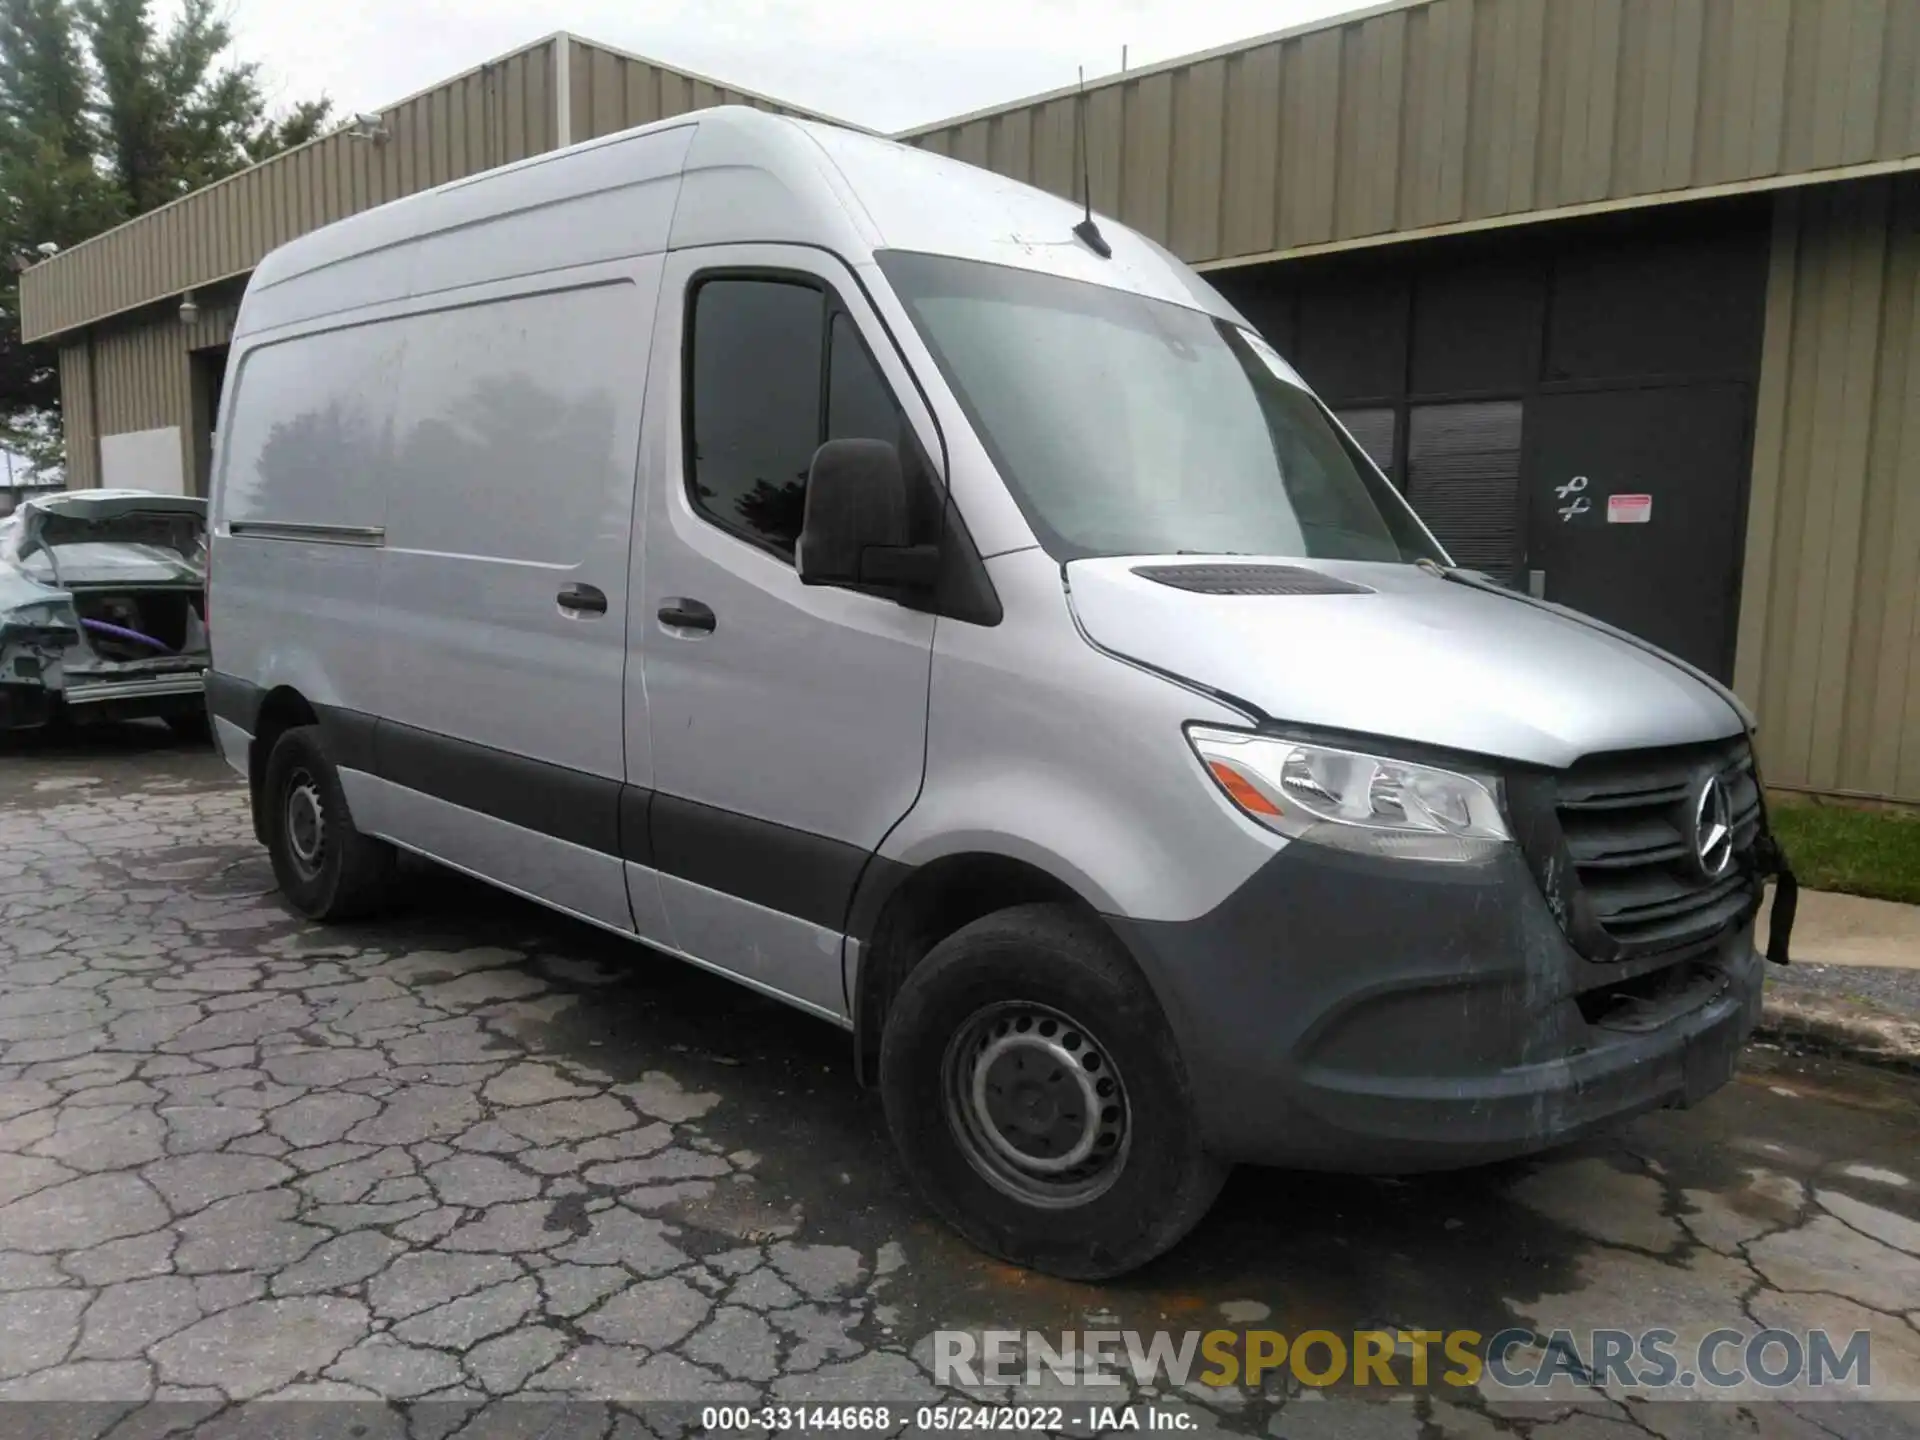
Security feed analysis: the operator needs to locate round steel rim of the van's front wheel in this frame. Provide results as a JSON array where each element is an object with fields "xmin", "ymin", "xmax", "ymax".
[{"xmin": 941, "ymin": 1000, "xmax": 1133, "ymax": 1210}]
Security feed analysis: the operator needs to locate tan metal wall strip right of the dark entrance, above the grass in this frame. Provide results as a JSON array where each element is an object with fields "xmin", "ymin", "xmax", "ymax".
[{"xmin": 1734, "ymin": 177, "xmax": 1920, "ymax": 803}]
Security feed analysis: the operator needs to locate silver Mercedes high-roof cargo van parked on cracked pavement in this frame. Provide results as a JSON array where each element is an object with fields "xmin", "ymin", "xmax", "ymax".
[{"xmin": 207, "ymin": 109, "xmax": 1786, "ymax": 1277}]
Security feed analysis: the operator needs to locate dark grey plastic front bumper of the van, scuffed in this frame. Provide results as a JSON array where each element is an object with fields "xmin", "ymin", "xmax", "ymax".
[{"xmin": 1114, "ymin": 843, "xmax": 1761, "ymax": 1173}]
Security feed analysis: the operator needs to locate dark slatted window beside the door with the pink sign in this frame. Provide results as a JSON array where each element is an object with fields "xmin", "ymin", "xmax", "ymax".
[{"xmin": 1407, "ymin": 399, "xmax": 1521, "ymax": 582}]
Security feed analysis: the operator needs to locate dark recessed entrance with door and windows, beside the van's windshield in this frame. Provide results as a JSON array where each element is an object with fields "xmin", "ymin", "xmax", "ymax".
[{"xmin": 1210, "ymin": 198, "xmax": 1770, "ymax": 678}]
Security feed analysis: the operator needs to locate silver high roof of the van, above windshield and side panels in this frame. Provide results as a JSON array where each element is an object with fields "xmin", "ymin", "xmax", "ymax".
[{"xmin": 238, "ymin": 106, "xmax": 1235, "ymax": 334}]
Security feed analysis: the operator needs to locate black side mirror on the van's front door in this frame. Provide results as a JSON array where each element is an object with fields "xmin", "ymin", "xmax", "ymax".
[{"xmin": 795, "ymin": 440, "xmax": 941, "ymax": 588}]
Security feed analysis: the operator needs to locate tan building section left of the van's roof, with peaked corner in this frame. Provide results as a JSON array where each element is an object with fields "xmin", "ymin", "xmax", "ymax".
[{"xmin": 21, "ymin": 35, "xmax": 840, "ymax": 503}]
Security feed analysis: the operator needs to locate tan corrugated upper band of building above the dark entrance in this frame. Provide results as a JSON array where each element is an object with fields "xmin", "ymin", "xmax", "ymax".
[{"xmin": 900, "ymin": 0, "xmax": 1920, "ymax": 263}]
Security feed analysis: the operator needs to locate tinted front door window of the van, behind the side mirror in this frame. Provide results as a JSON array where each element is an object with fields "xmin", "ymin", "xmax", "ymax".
[{"xmin": 685, "ymin": 275, "xmax": 927, "ymax": 561}]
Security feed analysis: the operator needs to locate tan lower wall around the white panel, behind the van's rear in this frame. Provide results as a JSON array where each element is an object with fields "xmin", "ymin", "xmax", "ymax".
[{"xmin": 60, "ymin": 303, "xmax": 238, "ymax": 490}]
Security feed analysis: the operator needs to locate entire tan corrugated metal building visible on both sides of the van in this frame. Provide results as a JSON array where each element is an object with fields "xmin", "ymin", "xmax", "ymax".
[{"xmin": 21, "ymin": 0, "xmax": 1920, "ymax": 803}]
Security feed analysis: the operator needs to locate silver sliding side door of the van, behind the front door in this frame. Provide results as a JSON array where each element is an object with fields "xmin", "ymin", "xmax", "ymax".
[{"xmin": 374, "ymin": 270, "xmax": 660, "ymax": 929}]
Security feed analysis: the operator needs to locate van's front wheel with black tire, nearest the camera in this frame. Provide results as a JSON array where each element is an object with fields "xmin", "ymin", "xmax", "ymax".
[{"xmin": 879, "ymin": 904, "xmax": 1229, "ymax": 1281}]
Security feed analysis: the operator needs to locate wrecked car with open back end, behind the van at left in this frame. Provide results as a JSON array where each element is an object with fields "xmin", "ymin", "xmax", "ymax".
[{"xmin": 0, "ymin": 490, "xmax": 207, "ymax": 735}]
